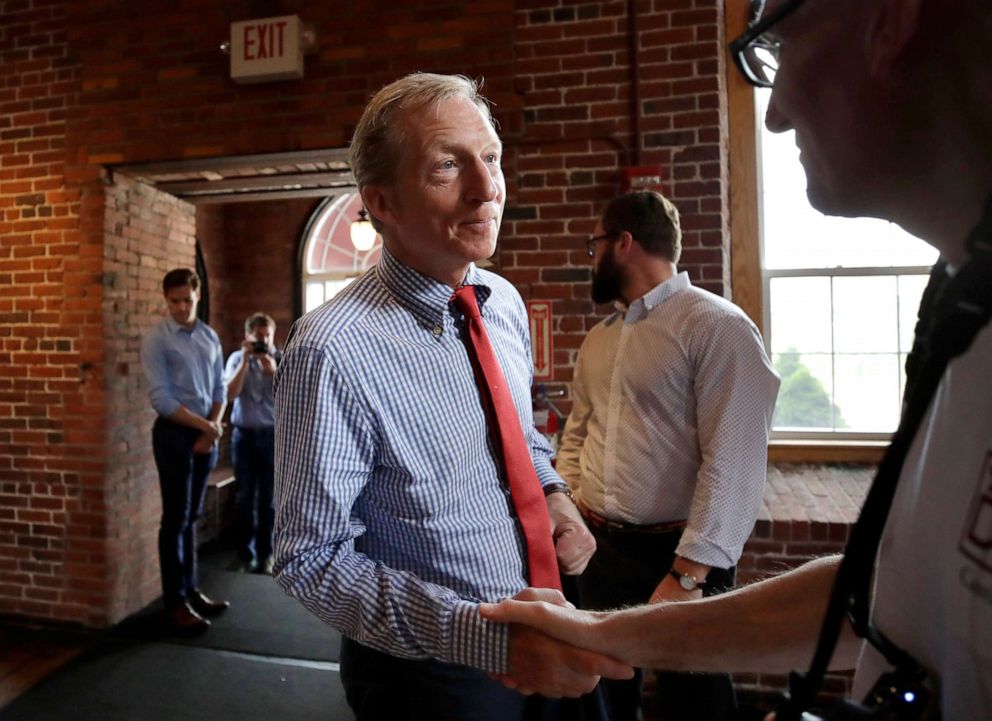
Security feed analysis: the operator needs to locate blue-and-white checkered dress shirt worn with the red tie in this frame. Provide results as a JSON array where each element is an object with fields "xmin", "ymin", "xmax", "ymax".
[{"xmin": 275, "ymin": 251, "xmax": 562, "ymax": 671}]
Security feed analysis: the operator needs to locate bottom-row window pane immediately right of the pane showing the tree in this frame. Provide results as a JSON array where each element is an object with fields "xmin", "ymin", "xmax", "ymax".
[{"xmin": 834, "ymin": 353, "xmax": 900, "ymax": 433}]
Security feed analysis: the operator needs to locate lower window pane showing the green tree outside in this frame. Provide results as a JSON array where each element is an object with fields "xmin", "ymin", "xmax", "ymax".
[{"xmin": 772, "ymin": 353, "xmax": 837, "ymax": 431}]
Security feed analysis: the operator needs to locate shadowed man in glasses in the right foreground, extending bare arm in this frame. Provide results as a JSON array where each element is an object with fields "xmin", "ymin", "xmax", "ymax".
[{"xmin": 483, "ymin": 0, "xmax": 992, "ymax": 721}]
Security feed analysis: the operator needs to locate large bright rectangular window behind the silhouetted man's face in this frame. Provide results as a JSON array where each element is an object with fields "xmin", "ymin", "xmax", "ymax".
[{"xmin": 756, "ymin": 90, "xmax": 937, "ymax": 439}]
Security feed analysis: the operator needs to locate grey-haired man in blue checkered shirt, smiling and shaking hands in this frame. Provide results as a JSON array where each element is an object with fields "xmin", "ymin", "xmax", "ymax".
[{"xmin": 275, "ymin": 74, "xmax": 628, "ymax": 721}]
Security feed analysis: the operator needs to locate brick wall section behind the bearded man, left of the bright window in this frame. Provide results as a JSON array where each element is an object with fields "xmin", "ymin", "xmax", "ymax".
[{"xmin": 499, "ymin": 0, "xmax": 730, "ymax": 394}]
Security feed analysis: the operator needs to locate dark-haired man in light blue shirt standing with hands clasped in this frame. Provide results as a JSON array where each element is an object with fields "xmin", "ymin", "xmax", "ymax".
[{"xmin": 141, "ymin": 268, "xmax": 229, "ymax": 634}]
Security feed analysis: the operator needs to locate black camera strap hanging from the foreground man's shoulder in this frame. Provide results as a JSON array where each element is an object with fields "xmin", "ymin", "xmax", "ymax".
[{"xmin": 776, "ymin": 197, "xmax": 992, "ymax": 721}]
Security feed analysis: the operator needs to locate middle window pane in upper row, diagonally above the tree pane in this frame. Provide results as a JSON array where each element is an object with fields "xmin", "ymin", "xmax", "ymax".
[{"xmin": 834, "ymin": 276, "xmax": 899, "ymax": 353}]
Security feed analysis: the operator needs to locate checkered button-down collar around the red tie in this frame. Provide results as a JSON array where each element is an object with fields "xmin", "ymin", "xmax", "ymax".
[{"xmin": 376, "ymin": 247, "xmax": 492, "ymax": 332}]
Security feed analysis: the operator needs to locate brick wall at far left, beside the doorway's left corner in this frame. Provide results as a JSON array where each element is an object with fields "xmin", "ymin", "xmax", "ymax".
[{"xmin": 0, "ymin": 2, "xmax": 107, "ymax": 624}]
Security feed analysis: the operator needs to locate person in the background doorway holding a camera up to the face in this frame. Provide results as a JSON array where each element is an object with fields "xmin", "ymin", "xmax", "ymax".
[{"xmin": 225, "ymin": 313, "xmax": 282, "ymax": 574}]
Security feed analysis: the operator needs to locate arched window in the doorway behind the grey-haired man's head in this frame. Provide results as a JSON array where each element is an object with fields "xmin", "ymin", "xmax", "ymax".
[{"xmin": 301, "ymin": 192, "xmax": 382, "ymax": 313}]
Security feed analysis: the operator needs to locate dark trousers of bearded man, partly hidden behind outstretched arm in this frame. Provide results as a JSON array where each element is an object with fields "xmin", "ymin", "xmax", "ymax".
[{"xmin": 579, "ymin": 528, "xmax": 737, "ymax": 721}]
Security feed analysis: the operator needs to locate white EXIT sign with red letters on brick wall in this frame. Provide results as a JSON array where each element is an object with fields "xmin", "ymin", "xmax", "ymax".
[{"xmin": 231, "ymin": 15, "xmax": 303, "ymax": 83}]
